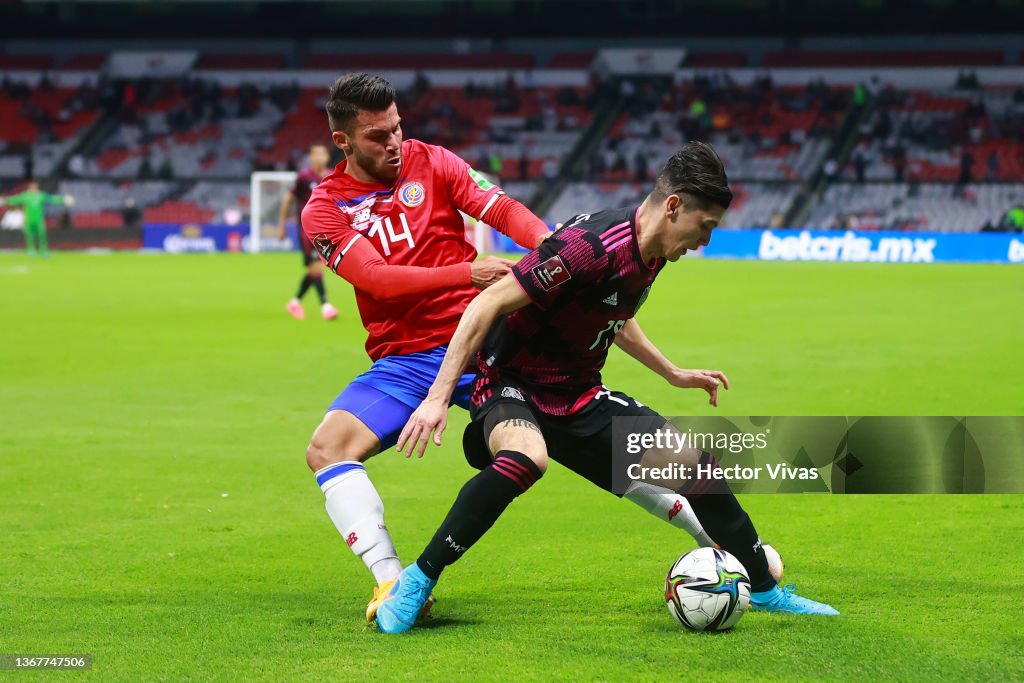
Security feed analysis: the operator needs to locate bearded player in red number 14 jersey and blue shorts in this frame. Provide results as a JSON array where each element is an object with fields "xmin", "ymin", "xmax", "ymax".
[{"xmin": 302, "ymin": 74, "xmax": 549, "ymax": 618}]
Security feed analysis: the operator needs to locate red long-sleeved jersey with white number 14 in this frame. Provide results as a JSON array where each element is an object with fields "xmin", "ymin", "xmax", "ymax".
[{"xmin": 302, "ymin": 139, "xmax": 548, "ymax": 360}]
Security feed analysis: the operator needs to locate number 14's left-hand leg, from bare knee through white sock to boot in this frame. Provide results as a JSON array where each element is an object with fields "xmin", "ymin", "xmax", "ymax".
[{"xmin": 306, "ymin": 411, "xmax": 401, "ymax": 620}]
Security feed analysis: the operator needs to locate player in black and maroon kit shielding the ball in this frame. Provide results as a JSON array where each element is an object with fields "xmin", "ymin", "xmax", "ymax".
[{"xmin": 377, "ymin": 142, "xmax": 839, "ymax": 633}]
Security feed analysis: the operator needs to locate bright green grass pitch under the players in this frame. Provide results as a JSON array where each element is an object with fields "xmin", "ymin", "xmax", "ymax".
[{"xmin": 0, "ymin": 254, "xmax": 1024, "ymax": 681}]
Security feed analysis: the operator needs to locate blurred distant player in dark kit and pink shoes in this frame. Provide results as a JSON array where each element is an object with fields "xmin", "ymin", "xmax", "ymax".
[{"xmin": 278, "ymin": 142, "xmax": 338, "ymax": 321}]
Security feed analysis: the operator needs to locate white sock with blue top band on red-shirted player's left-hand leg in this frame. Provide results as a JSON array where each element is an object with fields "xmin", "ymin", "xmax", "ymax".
[{"xmin": 315, "ymin": 462, "xmax": 401, "ymax": 585}]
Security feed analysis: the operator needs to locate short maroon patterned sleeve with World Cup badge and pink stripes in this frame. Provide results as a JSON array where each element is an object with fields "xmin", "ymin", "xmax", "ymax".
[{"xmin": 512, "ymin": 227, "xmax": 608, "ymax": 309}]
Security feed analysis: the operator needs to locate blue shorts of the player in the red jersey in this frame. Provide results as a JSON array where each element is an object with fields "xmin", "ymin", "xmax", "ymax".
[{"xmin": 327, "ymin": 345, "xmax": 476, "ymax": 453}]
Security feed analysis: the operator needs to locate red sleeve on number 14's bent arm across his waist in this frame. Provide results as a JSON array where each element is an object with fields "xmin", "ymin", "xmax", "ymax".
[{"xmin": 301, "ymin": 192, "xmax": 472, "ymax": 301}]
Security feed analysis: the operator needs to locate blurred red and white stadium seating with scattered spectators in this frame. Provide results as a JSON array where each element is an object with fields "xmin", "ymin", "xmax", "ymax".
[{"xmin": 0, "ymin": 44, "xmax": 1024, "ymax": 242}]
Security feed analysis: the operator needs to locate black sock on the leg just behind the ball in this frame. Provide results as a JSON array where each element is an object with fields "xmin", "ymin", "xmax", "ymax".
[{"xmin": 678, "ymin": 453, "xmax": 775, "ymax": 593}]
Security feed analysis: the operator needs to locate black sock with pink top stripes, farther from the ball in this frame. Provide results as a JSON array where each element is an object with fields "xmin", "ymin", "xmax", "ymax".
[{"xmin": 416, "ymin": 451, "xmax": 542, "ymax": 581}]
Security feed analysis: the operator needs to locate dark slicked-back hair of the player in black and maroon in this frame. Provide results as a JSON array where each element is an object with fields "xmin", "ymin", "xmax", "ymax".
[{"xmin": 650, "ymin": 142, "xmax": 732, "ymax": 210}]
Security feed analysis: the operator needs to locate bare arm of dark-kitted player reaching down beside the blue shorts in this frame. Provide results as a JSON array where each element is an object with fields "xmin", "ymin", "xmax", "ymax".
[{"xmin": 397, "ymin": 274, "xmax": 529, "ymax": 458}]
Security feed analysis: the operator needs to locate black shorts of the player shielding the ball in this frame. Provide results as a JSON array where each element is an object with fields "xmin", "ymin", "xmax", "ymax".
[{"xmin": 463, "ymin": 386, "xmax": 664, "ymax": 492}]
